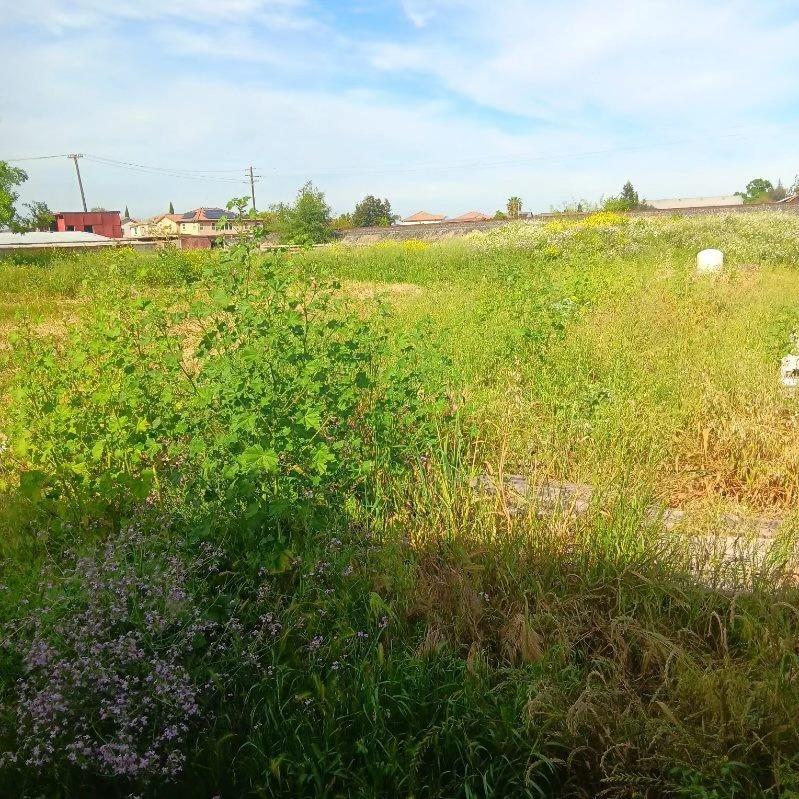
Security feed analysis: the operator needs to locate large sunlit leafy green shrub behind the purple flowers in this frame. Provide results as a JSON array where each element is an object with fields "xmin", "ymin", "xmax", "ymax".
[{"xmin": 3, "ymin": 244, "xmax": 442, "ymax": 536}]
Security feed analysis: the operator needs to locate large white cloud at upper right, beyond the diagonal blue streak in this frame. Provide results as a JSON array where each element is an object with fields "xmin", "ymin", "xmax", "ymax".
[{"xmin": 371, "ymin": 0, "xmax": 799, "ymax": 125}]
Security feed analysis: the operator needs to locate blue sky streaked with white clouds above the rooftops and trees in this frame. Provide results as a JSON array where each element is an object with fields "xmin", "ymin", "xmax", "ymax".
[{"xmin": 0, "ymin": 0, "xmax": 799, "ymax": 216}]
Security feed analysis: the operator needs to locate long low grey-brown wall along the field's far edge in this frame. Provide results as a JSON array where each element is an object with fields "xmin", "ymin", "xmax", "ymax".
[{"xmin": 336, "ymin": 203, "xmax": 799, "ymax": 244}]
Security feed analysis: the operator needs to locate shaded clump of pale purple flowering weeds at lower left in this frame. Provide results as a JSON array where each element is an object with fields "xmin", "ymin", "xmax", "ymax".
[{"xmin": 5, "ymin": 536, "xmax": 223, "ymax": 780}]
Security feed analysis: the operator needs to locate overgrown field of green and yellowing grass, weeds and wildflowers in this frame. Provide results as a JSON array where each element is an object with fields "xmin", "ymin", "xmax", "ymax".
[{"xmin": 0, "ymin": 214, "xmax": 799, "ymax": 799}]
